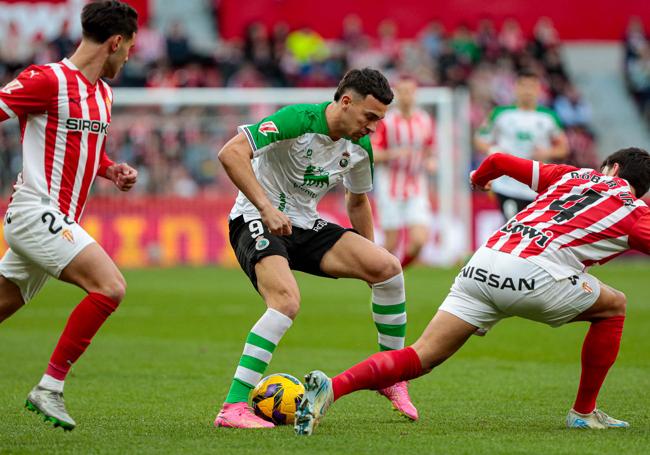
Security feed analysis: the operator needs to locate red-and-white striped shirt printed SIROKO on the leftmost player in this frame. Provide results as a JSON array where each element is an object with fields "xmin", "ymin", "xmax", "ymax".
[{"xmin": 0, "ymin": 59, "xmax": 113, "ymax": 221}]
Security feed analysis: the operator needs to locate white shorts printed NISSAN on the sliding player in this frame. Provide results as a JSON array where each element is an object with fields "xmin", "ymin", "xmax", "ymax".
[{"xmin": 439, "ymin": 247, "xmax": 600, "ymax": 332}]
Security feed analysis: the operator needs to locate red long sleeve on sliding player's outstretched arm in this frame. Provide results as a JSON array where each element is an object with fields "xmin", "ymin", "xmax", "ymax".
[{"xmin": 472, "ymin": 153, "xmax": 577, "ymax": 193}]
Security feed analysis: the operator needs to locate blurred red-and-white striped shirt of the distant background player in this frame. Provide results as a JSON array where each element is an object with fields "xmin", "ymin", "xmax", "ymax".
[{"xmin": 372, "ymin": 109, "xmax": 434, "ymax": 199}]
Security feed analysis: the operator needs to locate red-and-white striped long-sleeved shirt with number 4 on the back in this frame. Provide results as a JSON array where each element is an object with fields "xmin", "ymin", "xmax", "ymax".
[{"xmin": 472, "ymin": 153, "xmax": 650, "ymax": 280}]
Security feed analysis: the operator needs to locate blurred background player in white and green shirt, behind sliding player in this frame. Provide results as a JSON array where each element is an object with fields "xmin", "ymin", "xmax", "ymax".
[{"xmin": 474, "ymin": 70, "xmax": 569, "ymax": 220}]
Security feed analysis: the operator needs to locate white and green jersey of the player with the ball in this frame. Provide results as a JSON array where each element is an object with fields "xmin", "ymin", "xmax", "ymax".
[{"xmin": 230, "ymin": 102, "xmax": 373, "ymax": 229}]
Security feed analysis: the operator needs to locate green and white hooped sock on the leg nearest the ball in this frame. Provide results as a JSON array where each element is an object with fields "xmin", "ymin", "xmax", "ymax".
[{"xmin": 226, "ymin": 308, "xmax": 293, "ymax": 403}]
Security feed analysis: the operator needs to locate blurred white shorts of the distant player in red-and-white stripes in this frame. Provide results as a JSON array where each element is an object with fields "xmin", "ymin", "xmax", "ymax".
[{"xmin": 377, "ymin": 192, "xmax": 431, "ymax": 231}]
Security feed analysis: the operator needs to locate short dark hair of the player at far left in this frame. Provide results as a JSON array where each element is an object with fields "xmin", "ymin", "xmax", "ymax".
[{"xmin": 81, "ymin": 0, "xmax": 138, "ymax": 44}]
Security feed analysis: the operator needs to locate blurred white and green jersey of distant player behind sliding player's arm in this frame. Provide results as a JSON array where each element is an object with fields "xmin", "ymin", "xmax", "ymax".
[{"xmin": 478, "ymin": 106, "xmax": 562, "ymax": 201}]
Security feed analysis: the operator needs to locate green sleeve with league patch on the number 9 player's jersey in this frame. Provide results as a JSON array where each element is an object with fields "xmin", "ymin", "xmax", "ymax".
[{"xmin": 237, "ymin": 106, "xmax": 305, "ymax": 156}]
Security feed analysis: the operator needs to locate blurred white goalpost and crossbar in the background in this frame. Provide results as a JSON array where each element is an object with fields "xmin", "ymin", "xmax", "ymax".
[{"xmin": 113, "ymin": 87, "xmax": 472, "ymax": 266}]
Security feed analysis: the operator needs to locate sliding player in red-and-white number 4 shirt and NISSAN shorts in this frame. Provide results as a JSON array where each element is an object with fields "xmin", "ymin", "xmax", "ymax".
[{"xmin": 295, "ymin": 148, "xmax": 650, "ymax": 434}]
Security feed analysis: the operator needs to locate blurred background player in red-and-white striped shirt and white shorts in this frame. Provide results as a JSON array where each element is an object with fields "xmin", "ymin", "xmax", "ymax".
[{"xmin": 372, "ymin": 77, "xmax": 435, "ymax": 267}]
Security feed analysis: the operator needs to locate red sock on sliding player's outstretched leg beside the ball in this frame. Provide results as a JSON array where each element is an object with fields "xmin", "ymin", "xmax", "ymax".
[{"xmin": 332, "ymin": 347, "xmax": 423, "ymax": 400}]
